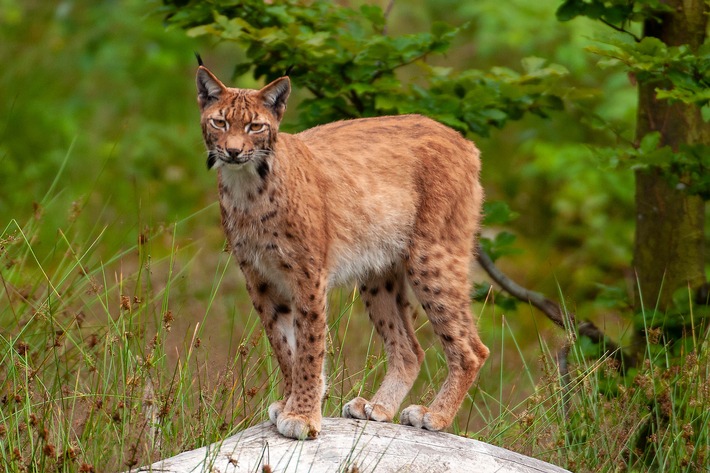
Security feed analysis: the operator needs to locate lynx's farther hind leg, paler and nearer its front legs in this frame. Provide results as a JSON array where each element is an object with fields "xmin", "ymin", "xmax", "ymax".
[{"xmin": 343, "ymin": 270, "xmax": 424, "ymax": 422}]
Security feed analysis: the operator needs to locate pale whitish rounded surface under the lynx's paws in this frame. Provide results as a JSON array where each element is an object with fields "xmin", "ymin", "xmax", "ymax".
[{"xmin": 132, "ymin": 418, "xmax": 569, "ymax": 473}]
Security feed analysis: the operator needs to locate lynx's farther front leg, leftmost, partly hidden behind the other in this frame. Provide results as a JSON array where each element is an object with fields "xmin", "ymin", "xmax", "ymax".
[{"xmin": 241, "ymin": 264, "xmax": 296, "ymax": 424}]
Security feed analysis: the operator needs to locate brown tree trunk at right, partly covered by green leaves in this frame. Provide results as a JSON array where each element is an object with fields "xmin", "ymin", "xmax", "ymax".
[{"xmin": 634, "ymin": 0, "xmax": 710, "ymax": 328}]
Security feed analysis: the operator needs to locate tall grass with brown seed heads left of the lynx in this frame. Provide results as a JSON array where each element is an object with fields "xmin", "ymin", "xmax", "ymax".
[{"xmin": 0, "ymin": 212, "xmax": 258, "ymax": 471}]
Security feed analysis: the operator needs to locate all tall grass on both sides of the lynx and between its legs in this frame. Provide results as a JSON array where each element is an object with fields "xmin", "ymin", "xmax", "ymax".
[{"xmin": 0, "ymin": 179, "xmax": 710, "ymax": 472}]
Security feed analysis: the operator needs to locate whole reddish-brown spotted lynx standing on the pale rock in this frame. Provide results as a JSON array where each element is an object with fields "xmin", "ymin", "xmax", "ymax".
[{"xmin": 197, "ymin": 66, "xmax": 489, "ymax": 439}]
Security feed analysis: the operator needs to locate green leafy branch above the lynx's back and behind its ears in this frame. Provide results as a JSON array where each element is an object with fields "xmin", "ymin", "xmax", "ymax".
[{"xmin": 159, "ymin": 0, "xmax": 567, "ymax": 136}]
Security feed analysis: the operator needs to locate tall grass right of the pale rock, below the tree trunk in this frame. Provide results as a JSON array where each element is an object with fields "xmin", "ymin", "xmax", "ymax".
[{"xmin": 474, "ymin": 298, "xmax": 710, "ymax": 473}]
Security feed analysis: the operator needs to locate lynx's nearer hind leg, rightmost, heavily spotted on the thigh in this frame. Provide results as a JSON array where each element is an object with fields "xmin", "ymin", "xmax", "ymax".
[{"xmin": 400, "ymin": 241, "xmax": 489, "ymax": 431}]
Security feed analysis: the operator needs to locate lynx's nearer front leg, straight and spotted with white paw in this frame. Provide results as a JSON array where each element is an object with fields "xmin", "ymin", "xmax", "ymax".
[{"xmin": 276, "ymin": 271, "xmax": 327, "ymax": 439}]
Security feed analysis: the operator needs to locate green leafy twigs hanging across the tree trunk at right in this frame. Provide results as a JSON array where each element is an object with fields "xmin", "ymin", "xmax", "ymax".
[{"xmin": 557, "ymin": 0, "xmax": 710, "ymax": 200}]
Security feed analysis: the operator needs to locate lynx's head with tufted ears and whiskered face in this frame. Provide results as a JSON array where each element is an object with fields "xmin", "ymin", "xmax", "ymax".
[{"xmin": 197, "ymin": 66, "xmax": 291, "ymax": 169}]
